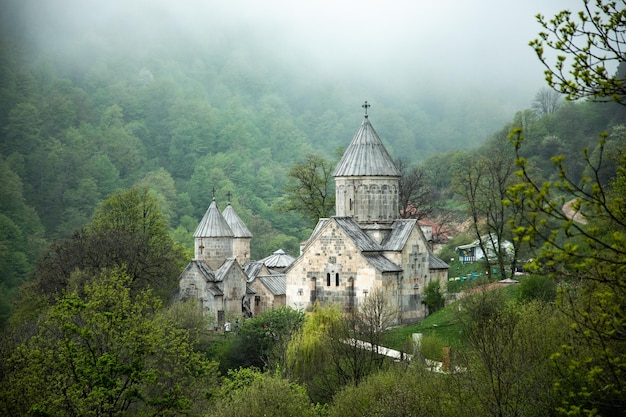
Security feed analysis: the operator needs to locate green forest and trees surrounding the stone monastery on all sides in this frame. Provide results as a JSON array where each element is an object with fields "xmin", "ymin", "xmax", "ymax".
[{"xmin": 0, "ymin": 2, "xmax": 626, "ymax": 416}]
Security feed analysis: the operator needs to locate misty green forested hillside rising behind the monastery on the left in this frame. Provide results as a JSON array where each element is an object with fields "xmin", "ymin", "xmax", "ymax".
[{"xmin": 0, "ymin": 2, "xmax": 520, "ymax": 250}]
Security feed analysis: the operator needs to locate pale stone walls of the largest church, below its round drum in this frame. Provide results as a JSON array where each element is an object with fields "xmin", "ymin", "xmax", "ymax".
[{"xmin": 286, "ymin": 214, "xmax": 438, "ymax": 323}]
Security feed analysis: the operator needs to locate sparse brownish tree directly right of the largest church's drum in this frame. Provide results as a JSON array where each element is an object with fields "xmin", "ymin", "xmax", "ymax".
[{"xmin": 395, "ymin": 158, "xmax": 435, "ymax": 220}]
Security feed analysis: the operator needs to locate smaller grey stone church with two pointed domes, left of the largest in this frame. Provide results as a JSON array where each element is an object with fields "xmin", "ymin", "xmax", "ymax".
[{"xmin": 174, "ymin": 198, "xmax": 294, "ymax": 327}]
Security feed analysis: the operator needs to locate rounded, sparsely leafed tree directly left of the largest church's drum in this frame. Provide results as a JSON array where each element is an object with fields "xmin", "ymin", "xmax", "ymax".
[{"xmin": 284, "ymin": 154, "xmax": 335, "ymax": 223}]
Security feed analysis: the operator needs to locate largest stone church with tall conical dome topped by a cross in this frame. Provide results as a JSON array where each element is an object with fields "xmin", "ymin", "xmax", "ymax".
[{"xmin": 285, "ymin": 103, "xmax": 448, "ymax": 323}]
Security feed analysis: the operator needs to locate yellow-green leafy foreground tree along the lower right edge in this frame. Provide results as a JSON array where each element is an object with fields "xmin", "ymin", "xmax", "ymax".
[{"xmin": 510, "ymin": 131, "xmax": 626, "ymax": 415}]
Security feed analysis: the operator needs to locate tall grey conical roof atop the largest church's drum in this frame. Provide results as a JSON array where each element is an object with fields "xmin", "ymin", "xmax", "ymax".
[{"xmin": 333, "ymin": 116, "xmax": 400, "ymax": 177}]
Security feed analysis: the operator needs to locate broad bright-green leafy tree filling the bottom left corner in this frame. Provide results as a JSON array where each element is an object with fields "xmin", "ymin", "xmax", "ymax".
[{"xmin": 0, "ymin": 270, "xmax": 217, "ymax": 416}]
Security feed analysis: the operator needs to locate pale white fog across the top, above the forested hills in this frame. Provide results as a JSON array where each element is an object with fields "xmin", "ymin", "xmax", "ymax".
[{"xmin": 5, "ymin": 0, "xmax": 573, "ymax": 136}]
